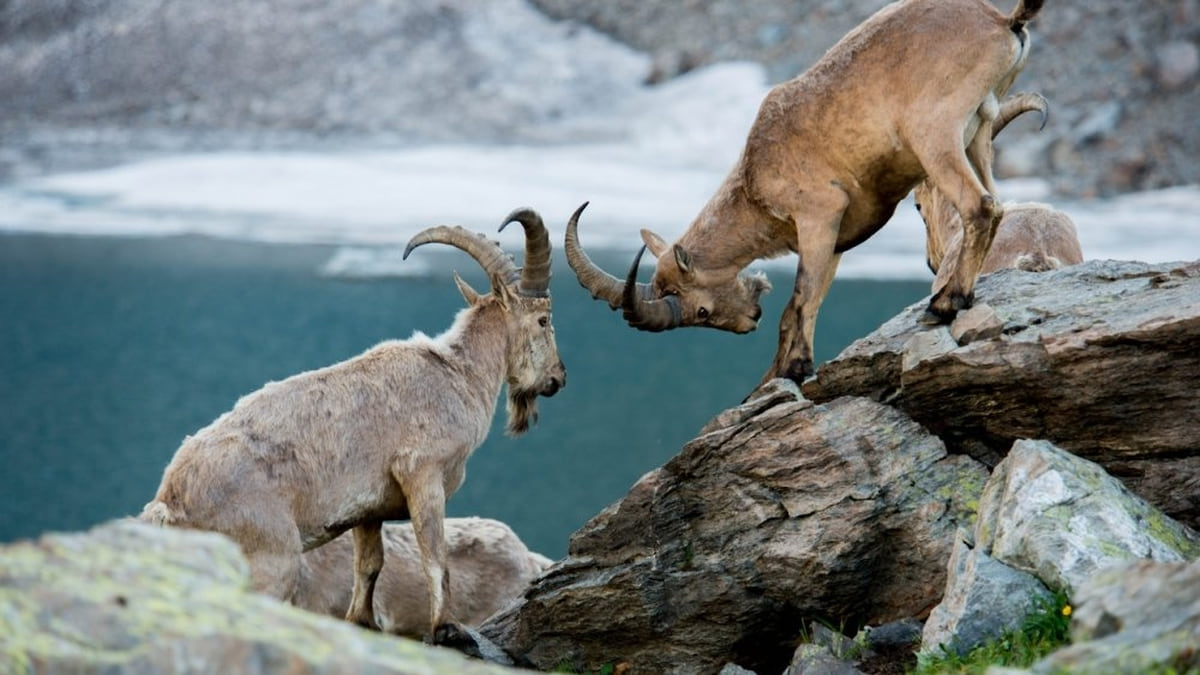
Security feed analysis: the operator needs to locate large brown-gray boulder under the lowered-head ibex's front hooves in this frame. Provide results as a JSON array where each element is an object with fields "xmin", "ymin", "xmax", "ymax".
[{"xmin": 481, "ymin": 381, "xmax": 985, "ymax": 673}]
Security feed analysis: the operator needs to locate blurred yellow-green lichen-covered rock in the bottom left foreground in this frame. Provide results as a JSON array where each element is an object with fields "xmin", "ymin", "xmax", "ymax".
[{"xmin": 0, "ymin": 520, "xmax": 512, "ymax": 675}]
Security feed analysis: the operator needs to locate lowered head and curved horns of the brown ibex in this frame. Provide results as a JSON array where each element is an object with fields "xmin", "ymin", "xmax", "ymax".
[{"xmin": 566, "ymin": 203, "xmax": 770, "ymax": 333}]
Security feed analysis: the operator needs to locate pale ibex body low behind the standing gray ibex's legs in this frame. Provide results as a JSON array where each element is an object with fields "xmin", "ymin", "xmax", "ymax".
[{"xmin": 294, "ymin": 518, "xmax": 552, "ymax": 639}]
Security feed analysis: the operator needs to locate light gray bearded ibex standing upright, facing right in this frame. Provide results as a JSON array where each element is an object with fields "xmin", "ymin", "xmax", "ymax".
[{"xmin": 140, "ymin": 209, "xmax": 566, "ymax": 640}]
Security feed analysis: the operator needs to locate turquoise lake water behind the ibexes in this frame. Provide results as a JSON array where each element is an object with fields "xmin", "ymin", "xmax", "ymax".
[{"xmin": 0, "ymin": 234, "xmax": 929, "ymax": 557}]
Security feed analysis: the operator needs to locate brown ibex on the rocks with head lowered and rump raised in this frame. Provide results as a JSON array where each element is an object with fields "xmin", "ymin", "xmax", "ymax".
[{"xmin": 566, "ymin": 0, "xmax": 1042, "ymax": 381}]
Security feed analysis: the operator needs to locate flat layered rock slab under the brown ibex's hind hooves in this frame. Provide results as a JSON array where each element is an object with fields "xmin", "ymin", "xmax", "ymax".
[{"xmin": 804, "ymin": 261, "xmax": 1200, "ymax": 528}]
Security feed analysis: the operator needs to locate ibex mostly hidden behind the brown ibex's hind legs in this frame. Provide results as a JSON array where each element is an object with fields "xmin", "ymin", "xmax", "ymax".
[{"xmin": 912, "ymin": 94, "xmax": 1084, "ymax": 275}]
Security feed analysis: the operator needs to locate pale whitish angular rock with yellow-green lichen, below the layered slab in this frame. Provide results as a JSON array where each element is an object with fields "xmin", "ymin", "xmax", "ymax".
[{"xmin": 976, "ymin": 441, "xmax": 1200, "ymax": 596}]
